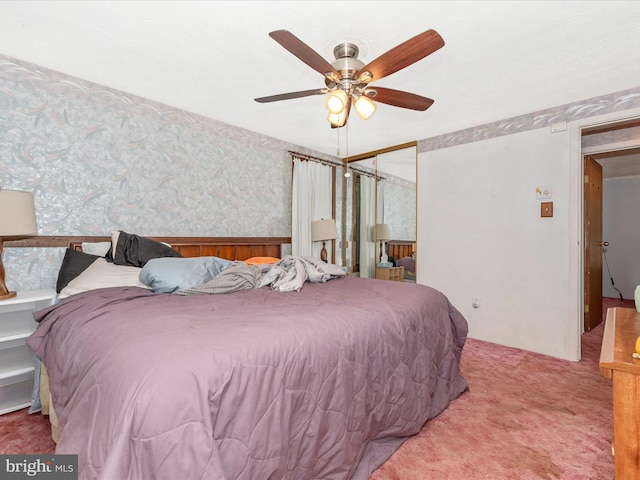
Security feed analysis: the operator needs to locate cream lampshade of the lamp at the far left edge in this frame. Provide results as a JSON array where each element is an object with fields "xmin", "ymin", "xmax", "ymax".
[{"xmin": 0, "ymin": 189, "xmax": 38, "ymax": 237}]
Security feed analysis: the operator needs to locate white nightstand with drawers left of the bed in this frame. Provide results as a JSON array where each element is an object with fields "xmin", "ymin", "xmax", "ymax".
[{"xmin": 0, "ymin": 290, "xmax": 56, "ymax": 415}]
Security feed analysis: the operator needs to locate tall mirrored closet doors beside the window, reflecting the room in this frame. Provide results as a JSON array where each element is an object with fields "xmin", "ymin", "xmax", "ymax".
[{"xmin": 343, "ymin": 142, "xmax": 417, "ymax": 282}]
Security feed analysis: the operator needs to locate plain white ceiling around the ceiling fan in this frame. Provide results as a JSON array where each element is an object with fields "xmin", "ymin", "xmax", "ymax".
[{"xmin": 0, "ymin": 0, "xmax": 640, "ymax": 156}]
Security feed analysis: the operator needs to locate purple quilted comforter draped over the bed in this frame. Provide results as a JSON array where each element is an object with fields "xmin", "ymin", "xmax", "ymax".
[{"xmin": 28, "ymin": 277, "xmax": 467, "ymax": 480}]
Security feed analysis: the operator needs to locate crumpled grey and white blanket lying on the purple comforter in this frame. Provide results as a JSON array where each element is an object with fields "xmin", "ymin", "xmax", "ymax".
[{"xmin": 174, "ymin": 255, "xmax": 346, "ymax": 295}]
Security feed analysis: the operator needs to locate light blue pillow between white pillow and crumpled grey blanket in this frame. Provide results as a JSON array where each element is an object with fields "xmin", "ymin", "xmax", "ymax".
[{"xmin": 140, "ymin": 257, "xmax": 231, "ymax": 293}]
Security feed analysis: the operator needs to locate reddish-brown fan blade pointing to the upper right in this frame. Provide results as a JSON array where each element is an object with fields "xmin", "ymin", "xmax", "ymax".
[{"xmin": 355, "ymin": 30, "xmax": 444, "ymax": 83}]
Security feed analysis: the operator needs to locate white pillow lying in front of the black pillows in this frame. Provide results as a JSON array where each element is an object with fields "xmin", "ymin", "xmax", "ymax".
[{"xmin": 58, "ymin": 258, "xmax": 149, "ymax": 298}]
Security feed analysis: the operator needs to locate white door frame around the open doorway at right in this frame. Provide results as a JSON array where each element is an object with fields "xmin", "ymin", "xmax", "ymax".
[{"xmin": 566, "ymin": 108, "xmax": 640, "ymax": 361}]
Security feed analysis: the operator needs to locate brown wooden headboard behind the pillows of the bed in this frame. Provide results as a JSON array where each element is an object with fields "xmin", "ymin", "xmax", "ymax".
[{"xmin": 68, "ymin": 237, "xmax": 291, "ymax": 260}]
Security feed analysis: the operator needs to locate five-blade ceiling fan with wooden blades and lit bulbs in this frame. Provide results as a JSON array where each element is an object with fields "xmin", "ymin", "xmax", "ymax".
[{"xmin": 255, "ymin": 30, "xmax": 444, "ymax": 128}]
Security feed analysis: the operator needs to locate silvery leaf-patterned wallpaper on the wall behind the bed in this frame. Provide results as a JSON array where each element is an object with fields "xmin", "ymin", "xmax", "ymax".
[{"xmin": 0, "ymin": 56, "xmax": 336, "ymax": 289}]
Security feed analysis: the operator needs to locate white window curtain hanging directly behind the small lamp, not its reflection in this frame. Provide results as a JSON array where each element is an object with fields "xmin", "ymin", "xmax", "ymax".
[{"xmin": 291, "ymin": 157, "xmax": 333, "ymax": 261}]
